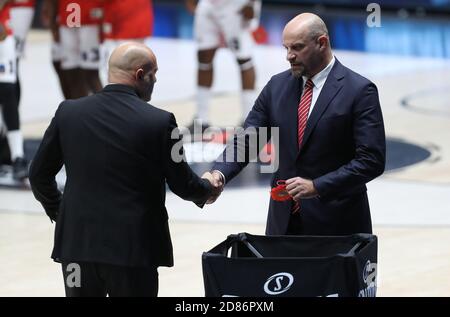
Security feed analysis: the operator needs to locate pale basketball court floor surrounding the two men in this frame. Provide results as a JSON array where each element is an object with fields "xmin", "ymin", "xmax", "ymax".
[{"xmin": 0, "ymin": 31, "xmax": 450, "ymax": 296}]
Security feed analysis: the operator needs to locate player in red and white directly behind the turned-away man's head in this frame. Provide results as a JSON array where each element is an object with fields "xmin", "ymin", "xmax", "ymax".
[{"xmin": 100, "ymin": 0, "xmax": 153, "ymax": 85}]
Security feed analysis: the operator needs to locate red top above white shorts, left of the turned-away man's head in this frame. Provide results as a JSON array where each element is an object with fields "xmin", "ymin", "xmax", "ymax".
[{"xmin": 58, "ymin": 0, "xmax": 103, "ymax": 25}]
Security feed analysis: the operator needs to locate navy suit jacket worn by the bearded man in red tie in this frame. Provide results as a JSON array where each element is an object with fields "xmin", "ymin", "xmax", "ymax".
[{"xmin": 213, "ymin": 60, "xmax": 386, "ymax": 235}]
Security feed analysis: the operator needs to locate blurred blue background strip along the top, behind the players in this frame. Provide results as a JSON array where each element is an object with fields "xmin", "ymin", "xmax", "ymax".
[{"xmin": 34, "ymin": 0, "xmax": 450, "ymax": 58}]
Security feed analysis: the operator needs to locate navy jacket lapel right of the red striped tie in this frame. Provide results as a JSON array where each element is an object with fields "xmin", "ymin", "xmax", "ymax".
[{"xmin": 299, "ymin": 59, "xmax": 345, "ymax": 154}]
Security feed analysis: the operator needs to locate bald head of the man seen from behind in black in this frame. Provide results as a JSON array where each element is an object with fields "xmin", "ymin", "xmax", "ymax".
[{"xmin": 108, "ymin": 42, "xmax": 158, "ymax": 101}]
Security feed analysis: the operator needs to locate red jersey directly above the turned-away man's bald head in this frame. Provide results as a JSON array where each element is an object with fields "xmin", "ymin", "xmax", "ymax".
[{"xmin": 103, "ymin": 0, "xmax": 153, "ymax": 40}]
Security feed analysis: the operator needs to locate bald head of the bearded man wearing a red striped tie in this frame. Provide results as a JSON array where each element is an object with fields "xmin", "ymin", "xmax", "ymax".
[{"xmin": 283, "ymin": 13, "xmax": 333, "ymax": 78}]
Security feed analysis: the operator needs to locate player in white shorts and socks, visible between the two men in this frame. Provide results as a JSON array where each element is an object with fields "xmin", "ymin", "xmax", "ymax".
[{"xmin": 186, "ymin": 0, "xmax": 261, "ymax": 131}]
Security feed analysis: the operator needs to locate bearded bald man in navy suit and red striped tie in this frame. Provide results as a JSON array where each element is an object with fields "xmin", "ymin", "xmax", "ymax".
[{"xmin": 208, "ymin": 13, "xmax": 386, "ymax": 235}]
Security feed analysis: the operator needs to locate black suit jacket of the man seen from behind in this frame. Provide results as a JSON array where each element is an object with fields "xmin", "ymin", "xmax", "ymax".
[{"xmin": 30, "ymin": 85, "xmax": 211, "ymax": 267}]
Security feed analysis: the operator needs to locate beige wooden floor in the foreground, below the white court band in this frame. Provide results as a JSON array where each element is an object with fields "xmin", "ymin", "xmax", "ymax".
[{"xmin": 0, "ymin": 213, "xmax": 450, "ymax": 297}]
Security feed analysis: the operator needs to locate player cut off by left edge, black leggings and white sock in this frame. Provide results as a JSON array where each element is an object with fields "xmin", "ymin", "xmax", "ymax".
[{"xmin": 0, "ymin": 0, "xmax": 28, "ymax": 180}]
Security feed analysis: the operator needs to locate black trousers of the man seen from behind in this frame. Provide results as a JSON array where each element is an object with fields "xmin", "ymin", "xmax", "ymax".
[{"xmin": 62, "ymin": 262, "xmax": 158, "ymax": 297}]
